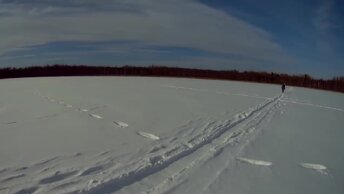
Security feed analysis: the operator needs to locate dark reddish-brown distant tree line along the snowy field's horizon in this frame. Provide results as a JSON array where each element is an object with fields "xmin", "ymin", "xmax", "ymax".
[{"xmin": 0, "ymin": 65, "xmax": 344, "ymax": 92}]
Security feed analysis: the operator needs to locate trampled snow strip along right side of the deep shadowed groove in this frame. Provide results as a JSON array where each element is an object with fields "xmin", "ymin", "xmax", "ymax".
[{"xmin": 142, "ymin": 94, "xmax": 280, "ymax": 194}]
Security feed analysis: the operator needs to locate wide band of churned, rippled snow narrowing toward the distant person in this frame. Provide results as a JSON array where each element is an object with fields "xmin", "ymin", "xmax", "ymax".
[{"xmin": 0, "ymin": 91, "xmax": 281, "ymax": 193}]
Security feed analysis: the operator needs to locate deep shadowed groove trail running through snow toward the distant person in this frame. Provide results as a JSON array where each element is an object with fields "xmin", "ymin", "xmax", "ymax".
[{"xmin": 85, "ymin": 95, "xmax": 282, "ymax": 194}]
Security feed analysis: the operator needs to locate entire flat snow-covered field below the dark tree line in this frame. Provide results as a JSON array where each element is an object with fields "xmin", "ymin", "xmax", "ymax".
[{"xmin": 0, "ymin": 77, "xmax": 344, "ymax": 194}]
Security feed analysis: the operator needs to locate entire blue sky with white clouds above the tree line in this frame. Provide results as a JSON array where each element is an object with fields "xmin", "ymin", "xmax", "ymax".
[{"xmin": 0, "ymin": 0, "xmax": 344, "ymax": 78}]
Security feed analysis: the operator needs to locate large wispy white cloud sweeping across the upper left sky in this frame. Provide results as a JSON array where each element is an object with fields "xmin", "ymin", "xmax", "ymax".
[{"xmin": 0, "ymin": 0, "xmax": 296, "ymax": 69}]
